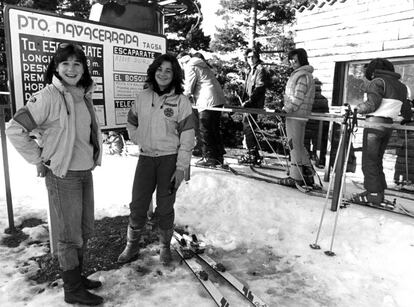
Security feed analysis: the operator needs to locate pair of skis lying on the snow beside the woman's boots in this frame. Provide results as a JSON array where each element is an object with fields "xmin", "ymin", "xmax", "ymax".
[{"xmin": 173, "ymin": 231, "xmax": 268, "ymax": 307}]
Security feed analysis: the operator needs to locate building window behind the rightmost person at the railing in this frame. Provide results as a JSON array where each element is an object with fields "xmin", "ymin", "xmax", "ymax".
[{"xmin": 343, "ymin": 57, "xmax": 414, "ymax": 106}]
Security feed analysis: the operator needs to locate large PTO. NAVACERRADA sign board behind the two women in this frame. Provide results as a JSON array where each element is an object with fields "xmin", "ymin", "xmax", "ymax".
[{"xmin": 5, "ymin": 6, "xmax": 166, "ymax": 129}]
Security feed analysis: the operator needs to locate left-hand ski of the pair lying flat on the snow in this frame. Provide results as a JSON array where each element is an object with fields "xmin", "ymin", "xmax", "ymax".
[{"xmin": 172, "ymin": 238, "xmax": 230, "ymax": 307}]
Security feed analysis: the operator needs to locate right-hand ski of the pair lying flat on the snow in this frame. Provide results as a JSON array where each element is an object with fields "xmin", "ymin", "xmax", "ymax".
[{"xmin": 174, "ymin": 231, "xmax": 268, "ymax": 307}]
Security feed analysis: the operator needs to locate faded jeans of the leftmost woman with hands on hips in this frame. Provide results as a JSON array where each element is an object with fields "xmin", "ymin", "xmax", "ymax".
[{"xmin": 46, "ymin": 170, "xmax": 94, "ymax": 271}]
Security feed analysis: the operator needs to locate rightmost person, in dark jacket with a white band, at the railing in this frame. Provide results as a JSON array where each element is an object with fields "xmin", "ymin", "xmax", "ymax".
[{"xmin": 353, "ymin": 58, "xmax": 412, "ymax": 205}]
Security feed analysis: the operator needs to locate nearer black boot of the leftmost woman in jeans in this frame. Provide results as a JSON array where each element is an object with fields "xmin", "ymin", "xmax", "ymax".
[{"xmin": 62, "ymin": 267, "xmax": 103, "ymax": 305}]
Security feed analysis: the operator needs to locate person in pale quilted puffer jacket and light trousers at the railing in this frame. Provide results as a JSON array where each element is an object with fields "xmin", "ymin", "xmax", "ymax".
[{"xmin": 282, "ymin": 48, "xmax": 315, "ymax": 186}]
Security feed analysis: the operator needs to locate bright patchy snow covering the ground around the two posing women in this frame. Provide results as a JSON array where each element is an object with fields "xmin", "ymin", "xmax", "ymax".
[{"xmin": 0, "ymin": 140, "xmax": 414, "ymax": 307}]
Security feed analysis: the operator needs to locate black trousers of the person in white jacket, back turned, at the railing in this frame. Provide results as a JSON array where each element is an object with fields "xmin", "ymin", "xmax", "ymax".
[{"xmin": 199, "ymin": 106, "xmax": 225, "ymax": 159}]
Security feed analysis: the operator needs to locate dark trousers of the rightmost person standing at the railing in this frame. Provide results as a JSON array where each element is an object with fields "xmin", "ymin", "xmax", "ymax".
[{"xmin": 362, "ymin": 117, "xmax": 392, "ymax": 193}]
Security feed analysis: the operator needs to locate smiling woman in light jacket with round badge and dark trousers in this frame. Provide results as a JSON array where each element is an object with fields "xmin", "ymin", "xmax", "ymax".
[{"xmin": 118, "ymin": 54, "xmax": 195, "ymax": 265}]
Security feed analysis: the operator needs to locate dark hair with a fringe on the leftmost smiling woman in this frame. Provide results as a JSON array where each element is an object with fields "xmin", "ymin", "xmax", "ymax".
[{"xmin": 45, "ymin": 43, "xmax": 93, "ymax": 88}]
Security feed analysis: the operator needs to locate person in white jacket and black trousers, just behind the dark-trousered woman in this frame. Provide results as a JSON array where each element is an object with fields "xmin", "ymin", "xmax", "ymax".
[{"xmin": 179, "ymin": 53, "xmax": 225, "ymax": 166}]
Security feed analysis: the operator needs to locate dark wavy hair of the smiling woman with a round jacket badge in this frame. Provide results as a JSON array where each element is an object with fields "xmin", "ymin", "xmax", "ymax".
[{"xmin": 147, "ymin": 53, "xmax": 184, "ymax": 95}]
